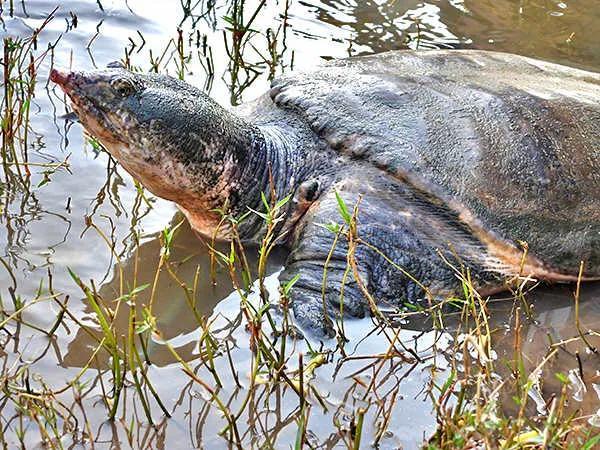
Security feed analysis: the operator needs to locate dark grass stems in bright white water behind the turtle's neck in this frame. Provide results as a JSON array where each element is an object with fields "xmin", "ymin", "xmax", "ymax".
[{"xmin": 123, "ymin": 0, "xmax": 294, "ymax": 100}]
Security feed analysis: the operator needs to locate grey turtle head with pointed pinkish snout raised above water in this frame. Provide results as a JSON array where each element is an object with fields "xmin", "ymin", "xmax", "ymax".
[{"xmin": 50, "ymin": 64, "xmax": 262, "ymax": 239}]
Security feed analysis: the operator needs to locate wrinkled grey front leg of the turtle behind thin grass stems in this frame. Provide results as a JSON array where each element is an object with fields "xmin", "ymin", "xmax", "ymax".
[{"xmin": 280, "ymin": 183, "xmax": 476, "ymax": 336}]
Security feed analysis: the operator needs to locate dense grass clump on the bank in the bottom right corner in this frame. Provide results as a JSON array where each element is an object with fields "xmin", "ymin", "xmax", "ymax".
[{"xmin": 426, "ymin": 264, "xmax": 600, "ymax": 450}]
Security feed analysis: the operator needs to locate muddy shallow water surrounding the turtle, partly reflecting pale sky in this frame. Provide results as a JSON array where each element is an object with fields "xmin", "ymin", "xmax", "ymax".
[{"xmin": 0, "ymin": 0, "xmax": 600, "ymax": 448}]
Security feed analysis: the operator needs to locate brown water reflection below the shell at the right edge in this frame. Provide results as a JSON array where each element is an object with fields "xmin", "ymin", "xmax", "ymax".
[{"xmin": 491, "ymin": 283, "xmax": 600, "ymax": 415}]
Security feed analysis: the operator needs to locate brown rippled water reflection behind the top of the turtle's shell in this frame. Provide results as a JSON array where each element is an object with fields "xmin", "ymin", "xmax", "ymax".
[{"xmin": 294, "ymin": 0, "xmax": 600, "ymax": 70}]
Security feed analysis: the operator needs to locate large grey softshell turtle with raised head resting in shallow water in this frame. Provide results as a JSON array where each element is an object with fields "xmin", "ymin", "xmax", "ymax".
[{"xmin": 51, "ymin": 50, "xmax": 600, "ymax": 335}]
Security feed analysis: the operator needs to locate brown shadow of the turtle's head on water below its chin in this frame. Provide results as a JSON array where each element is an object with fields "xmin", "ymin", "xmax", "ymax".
[{"xmin": 63, "ymin": 218, "xmax": 283, "ymax": 367}]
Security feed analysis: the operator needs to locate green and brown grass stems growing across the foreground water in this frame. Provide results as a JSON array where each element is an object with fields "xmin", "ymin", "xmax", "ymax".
[{"xmin": 5, "ymin": 187, "xmax": 597, "ymax": 449}]
